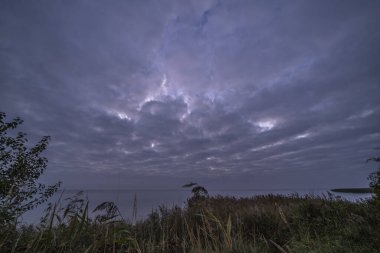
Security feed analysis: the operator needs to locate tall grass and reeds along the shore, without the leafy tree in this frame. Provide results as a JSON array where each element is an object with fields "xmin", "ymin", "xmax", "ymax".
[{"xmin": 0, "ymin": 191, "xmax": 380, "ymax": 253}]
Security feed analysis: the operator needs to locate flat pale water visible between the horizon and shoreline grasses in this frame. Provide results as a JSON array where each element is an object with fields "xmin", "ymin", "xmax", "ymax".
[{"xmin": 19, "ymin": 189, "xmax": 372, "ymax": 223}]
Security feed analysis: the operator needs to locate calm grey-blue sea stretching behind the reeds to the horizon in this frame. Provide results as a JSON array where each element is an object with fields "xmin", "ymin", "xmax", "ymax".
[{"xmin": 20, "ymin": 188, "xmax": 372, "ymax": 225}]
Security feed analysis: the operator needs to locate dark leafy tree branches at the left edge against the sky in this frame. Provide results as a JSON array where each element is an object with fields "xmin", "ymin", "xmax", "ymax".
[{"xmin": 0, "ymin": 112, "xmax": 59, "ymax": 226}]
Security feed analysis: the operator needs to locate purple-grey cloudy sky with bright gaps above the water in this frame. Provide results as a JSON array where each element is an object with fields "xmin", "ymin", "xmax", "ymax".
[{"xmin": 0, "ymin": 0, "xmax": 380, "ymax": 189}]
